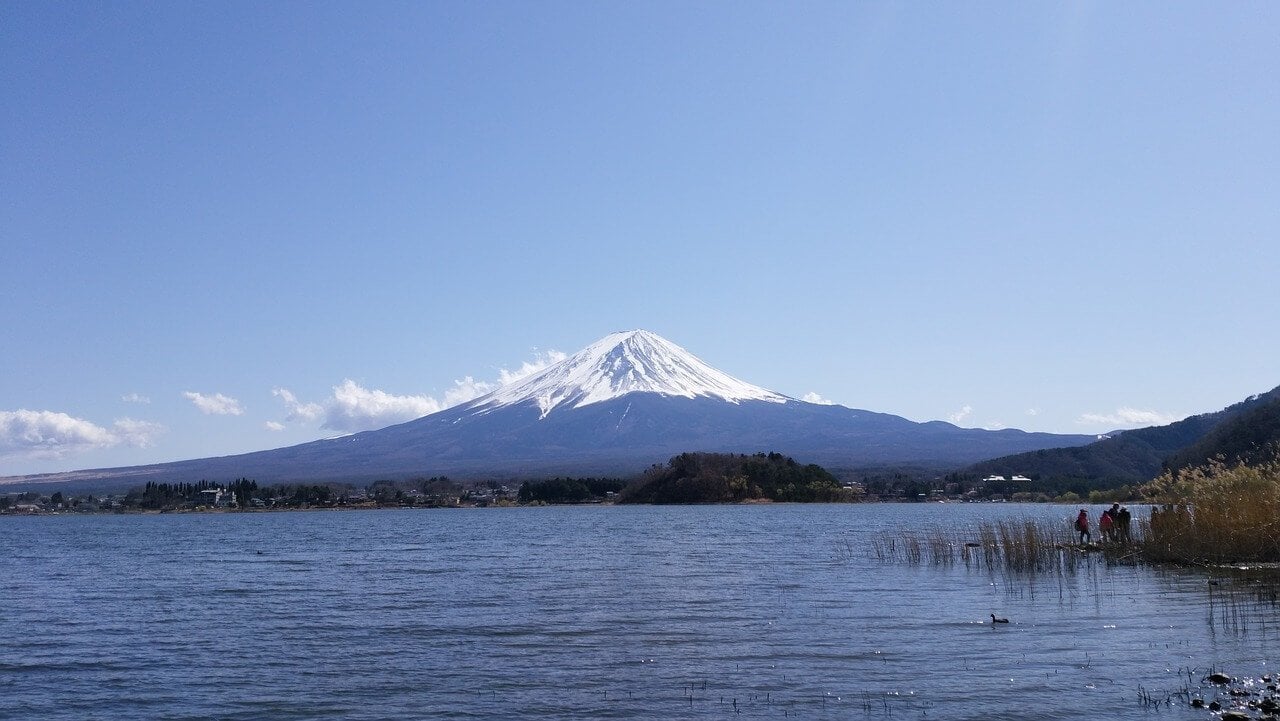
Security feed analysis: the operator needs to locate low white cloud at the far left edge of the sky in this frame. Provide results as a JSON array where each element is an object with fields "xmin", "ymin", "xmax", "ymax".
[{"xmin": 0, "ymin": 409, "xmax": 165, "ymax": 458}]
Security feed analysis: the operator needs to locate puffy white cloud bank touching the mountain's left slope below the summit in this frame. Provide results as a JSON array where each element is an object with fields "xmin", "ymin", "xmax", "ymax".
[{"xmin": 280, "ymin": 351, "xmax": 568, "ymax": 433}]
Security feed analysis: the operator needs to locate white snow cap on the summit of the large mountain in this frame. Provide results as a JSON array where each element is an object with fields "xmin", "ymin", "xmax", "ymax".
[{"xmin": 470, "ymin": 330, "xmax": 792, "ymax": 417}]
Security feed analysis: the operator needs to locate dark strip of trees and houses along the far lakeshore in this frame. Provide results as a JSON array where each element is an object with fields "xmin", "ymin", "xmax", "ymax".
[{"xmin": 0, "ymin": 453, "xmax": 1162, "ymax": 514}]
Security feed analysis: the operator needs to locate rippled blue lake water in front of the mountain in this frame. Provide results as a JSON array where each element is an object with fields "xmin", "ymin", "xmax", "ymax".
[{"xmin": 0, "ymin": 505, "xmax": 1277, "ymax": 720}]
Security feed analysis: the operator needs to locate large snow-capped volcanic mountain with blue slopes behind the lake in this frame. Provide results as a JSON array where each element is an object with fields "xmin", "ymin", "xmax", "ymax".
[{"xmin": 10, "ymin": 330, "xmax": 1094, "ymax": 483}]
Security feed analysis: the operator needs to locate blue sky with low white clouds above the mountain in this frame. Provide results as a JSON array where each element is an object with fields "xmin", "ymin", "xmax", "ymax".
[{"xmin": 0, "ymin": 3, "xmax": 1280, "ymax": 475}]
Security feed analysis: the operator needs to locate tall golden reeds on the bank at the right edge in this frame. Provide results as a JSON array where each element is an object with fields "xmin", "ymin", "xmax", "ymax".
[{"xmin": 1142, "ymin": 458, "xmax": 1280, "ymax": 563}]
